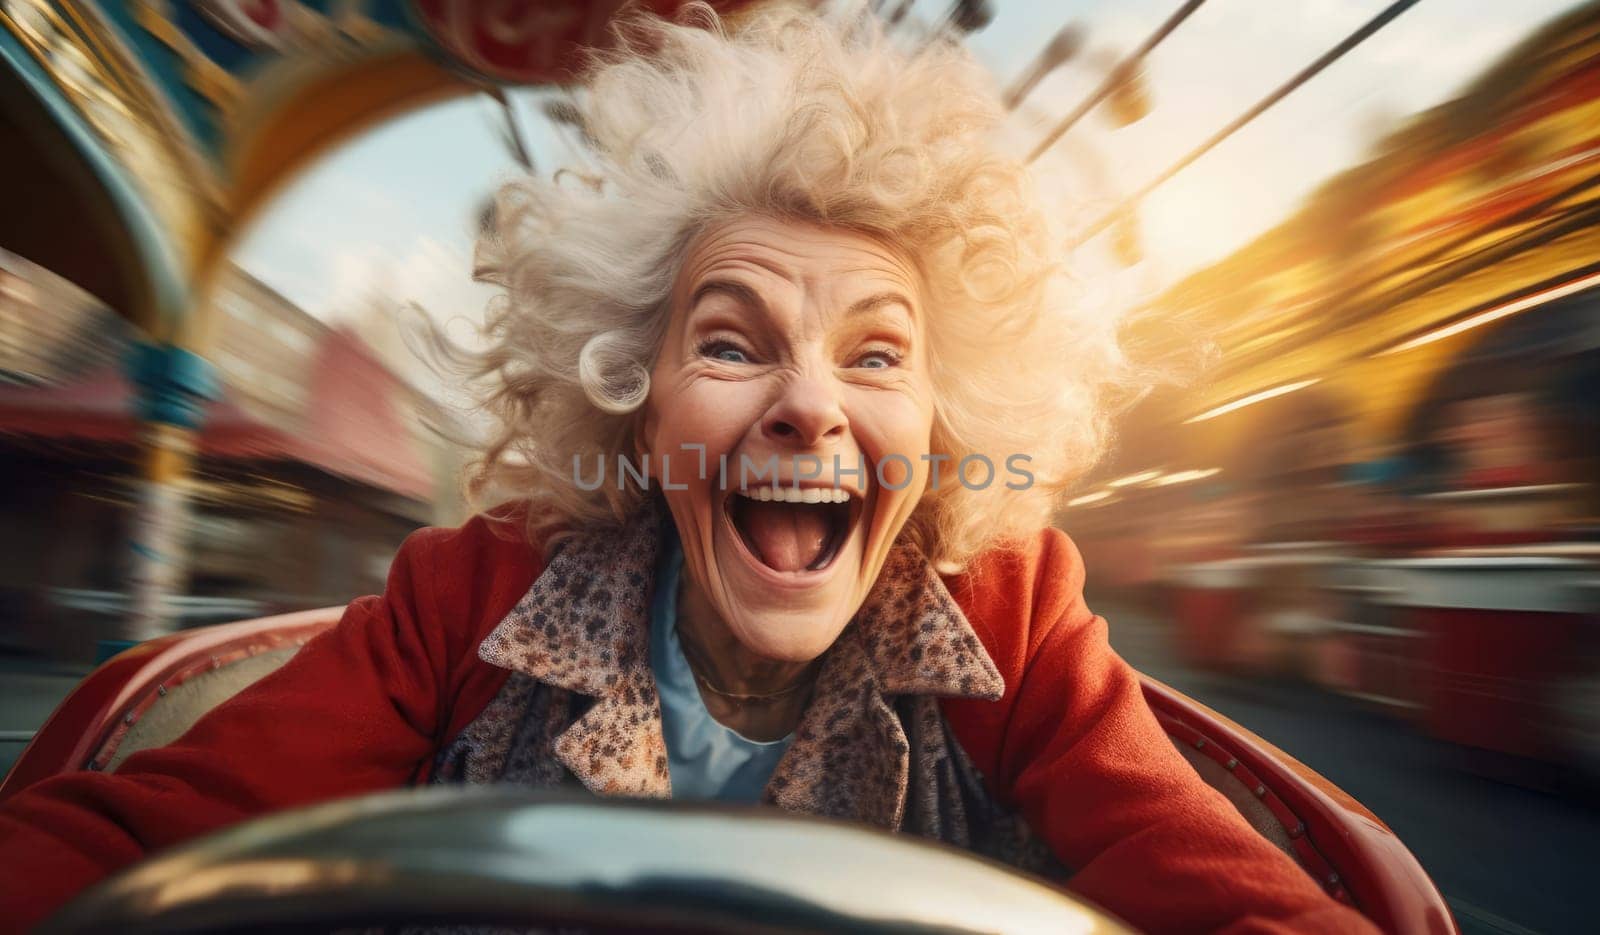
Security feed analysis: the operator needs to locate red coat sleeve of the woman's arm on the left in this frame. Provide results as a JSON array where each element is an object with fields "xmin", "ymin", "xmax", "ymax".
[{"xmin": 0, "ymin": 530, "xmax": 464, "ymax": 930}]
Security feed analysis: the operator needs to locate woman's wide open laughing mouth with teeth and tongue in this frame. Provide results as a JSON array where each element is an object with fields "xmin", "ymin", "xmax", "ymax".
[{"xmin": 726, "ymin": 487, "xmax": 859, "ymax": 573}]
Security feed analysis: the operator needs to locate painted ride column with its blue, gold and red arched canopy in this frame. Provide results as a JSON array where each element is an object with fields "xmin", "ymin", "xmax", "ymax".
[{"xmin": 0, "ymin": 0, "xmax": 758, "ymax": 653}]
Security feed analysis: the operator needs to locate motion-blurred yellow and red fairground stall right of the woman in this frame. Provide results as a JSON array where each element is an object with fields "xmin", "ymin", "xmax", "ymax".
[{"xmin": 1062, "ymin": 5, "xmax": 1600, "ymax": 781}]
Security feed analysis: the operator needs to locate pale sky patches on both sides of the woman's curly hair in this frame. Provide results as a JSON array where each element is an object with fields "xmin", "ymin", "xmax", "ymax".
[{"xmin": 225, "ymin": 0, "xmax": 1576, "ymax": 387}]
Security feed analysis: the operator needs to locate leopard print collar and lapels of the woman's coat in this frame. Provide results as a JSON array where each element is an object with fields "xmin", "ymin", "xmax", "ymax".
[{"xmin": 478, "ymin": 501, "xmax": 1005, "ymax": 828}]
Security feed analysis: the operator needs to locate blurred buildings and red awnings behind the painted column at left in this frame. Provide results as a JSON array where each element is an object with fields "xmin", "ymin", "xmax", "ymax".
[{"xmin": 0, "ymin": 253, "xmax": 459, "ymax": 660}]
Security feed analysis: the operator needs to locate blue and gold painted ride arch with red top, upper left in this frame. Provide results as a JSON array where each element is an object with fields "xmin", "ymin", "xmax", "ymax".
[{"xmin": 0, "ymin": 0, "xmax": 723, "ymax": 341}]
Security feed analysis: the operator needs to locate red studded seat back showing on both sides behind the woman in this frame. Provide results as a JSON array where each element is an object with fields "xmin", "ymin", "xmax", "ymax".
[{"xmin": 0, "ymin": 607, "xmax": 1458, "ymax": 935}]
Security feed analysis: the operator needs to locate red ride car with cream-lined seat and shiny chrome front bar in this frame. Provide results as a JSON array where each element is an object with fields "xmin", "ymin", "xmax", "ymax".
[{"xmin": 0, "ymin": 608, "xmax": 1456, "ymax": 935}]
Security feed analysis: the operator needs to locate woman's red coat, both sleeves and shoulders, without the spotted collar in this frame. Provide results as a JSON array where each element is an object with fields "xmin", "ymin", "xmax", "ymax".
[{"xmin": 0, "ymin": 520, "xmax": 1373, "ymax": 932}]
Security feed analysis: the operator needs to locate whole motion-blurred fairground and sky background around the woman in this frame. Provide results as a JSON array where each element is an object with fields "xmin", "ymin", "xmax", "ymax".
[{"xmin": 0, "ymin": 0, "xmax": 1600, "ymax": 933}]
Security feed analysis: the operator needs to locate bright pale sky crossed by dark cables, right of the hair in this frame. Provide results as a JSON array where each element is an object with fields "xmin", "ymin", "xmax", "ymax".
[{"xmin": 953, "ymin": 0, "xmax": 1576, "ymax": 285}]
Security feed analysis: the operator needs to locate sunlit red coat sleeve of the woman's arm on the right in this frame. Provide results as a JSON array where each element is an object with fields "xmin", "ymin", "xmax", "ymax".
[{"xmin": 966, "ymin": 530, "xmax": 1376, "ymax": 933}]
